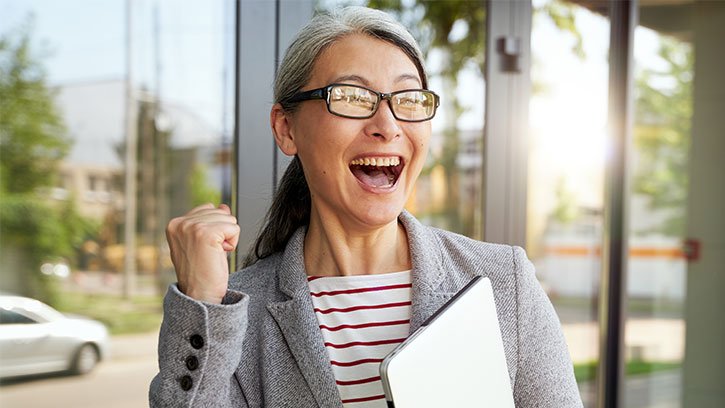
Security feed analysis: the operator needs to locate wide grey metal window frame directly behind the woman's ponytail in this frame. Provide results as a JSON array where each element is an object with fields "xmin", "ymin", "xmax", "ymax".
[{"xmin": 230, "ymin": 0, "xmax": 314, "ymax": 270}]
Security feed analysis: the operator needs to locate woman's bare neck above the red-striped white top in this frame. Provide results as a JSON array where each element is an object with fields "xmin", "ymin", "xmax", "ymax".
[{"xmin": 304, "ymin": 206, "xmax": 411, "ymax": 276}]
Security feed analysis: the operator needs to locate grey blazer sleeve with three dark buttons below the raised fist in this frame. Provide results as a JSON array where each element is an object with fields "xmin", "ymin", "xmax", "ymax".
[{"xmin": 149, "ymin": 283, "xmax": 249, "ymax": 407}]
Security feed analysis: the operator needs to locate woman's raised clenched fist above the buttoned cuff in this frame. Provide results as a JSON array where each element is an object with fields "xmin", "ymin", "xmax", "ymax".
[{"xmin": 166, "ymin": 203, "xmax": 239, "ymax": 303}]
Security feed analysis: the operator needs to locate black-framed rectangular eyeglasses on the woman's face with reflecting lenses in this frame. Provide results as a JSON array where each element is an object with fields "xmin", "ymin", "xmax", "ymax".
[{"xmin": 287, "ymin": 84, "xmax": 440, "ymax": 122}]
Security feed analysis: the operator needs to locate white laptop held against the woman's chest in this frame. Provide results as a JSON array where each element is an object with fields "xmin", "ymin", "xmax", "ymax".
[{"xmin": 380, "ymin": 276, "xmax": 514, "ymax": 408}]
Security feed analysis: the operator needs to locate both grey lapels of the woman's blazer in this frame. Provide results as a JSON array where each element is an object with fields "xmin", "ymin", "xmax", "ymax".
[{"xmin": 267, "ymin": 210, "xmax": 453, "ymax": 407}]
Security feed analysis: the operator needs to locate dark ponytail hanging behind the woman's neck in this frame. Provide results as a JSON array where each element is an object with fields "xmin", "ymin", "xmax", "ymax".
[{"xmin": 242, "ymin": 156, "xmax": 312, "ymax": 268}]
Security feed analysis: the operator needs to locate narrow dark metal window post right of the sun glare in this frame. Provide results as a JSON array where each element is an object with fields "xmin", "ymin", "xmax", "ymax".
[{"xmin": 597, "ymin": 0, "xmax": 639, "ymax": 408}]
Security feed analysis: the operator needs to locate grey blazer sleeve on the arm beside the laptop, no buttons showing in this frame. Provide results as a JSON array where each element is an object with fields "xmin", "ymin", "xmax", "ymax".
[{"xmin": 514, "ymin": 247, "xmax": 582, "ymax": 408}]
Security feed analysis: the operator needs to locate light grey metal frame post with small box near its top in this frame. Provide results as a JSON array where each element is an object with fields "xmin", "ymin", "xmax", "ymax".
[{"xmin": 482, "ymin": 0, "xmax": 532, "ymax": 247}]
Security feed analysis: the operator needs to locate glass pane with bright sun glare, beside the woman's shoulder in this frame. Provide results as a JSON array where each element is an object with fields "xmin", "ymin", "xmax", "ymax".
[{"xmin": 526, "ymin": 0, "xmax": 610, "ymax": 407}]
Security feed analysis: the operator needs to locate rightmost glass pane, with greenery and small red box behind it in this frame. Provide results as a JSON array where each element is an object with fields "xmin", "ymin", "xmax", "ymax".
[{"xmin": 624, "ymin": 2, "xmax": 725, "ymax": 407}]
